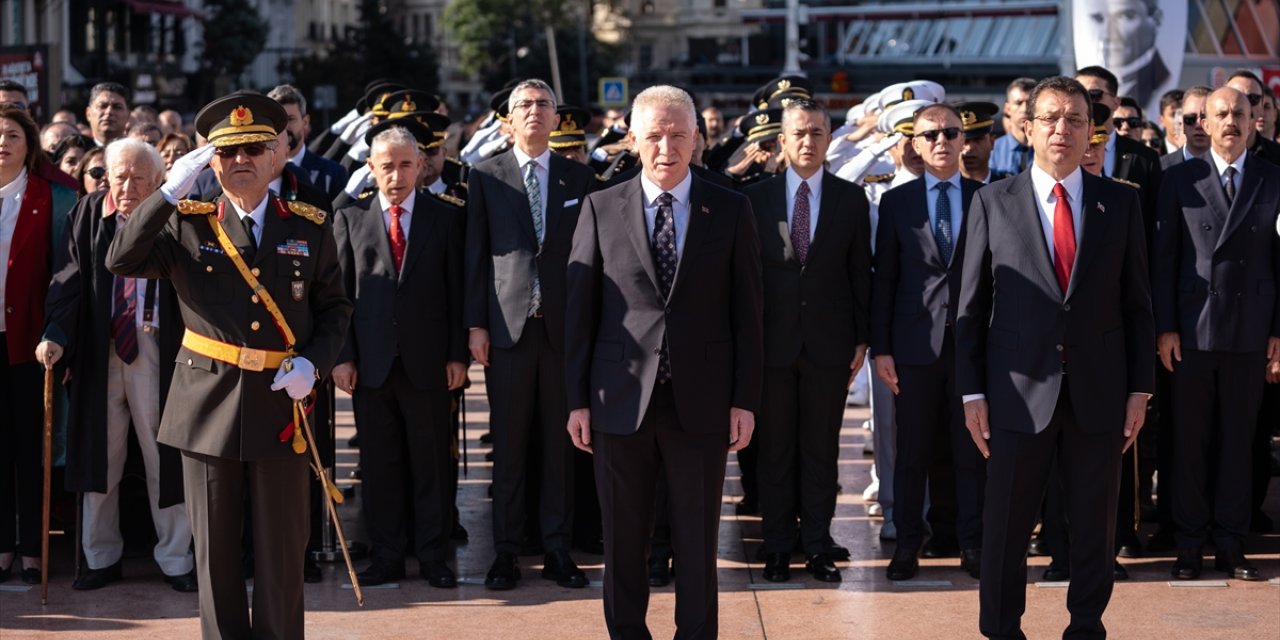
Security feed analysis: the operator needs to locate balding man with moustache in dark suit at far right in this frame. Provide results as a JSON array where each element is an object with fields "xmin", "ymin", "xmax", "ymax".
[{"xmin": 1152, "ymin": 87, "xmax": 1280, "ymax": 580}]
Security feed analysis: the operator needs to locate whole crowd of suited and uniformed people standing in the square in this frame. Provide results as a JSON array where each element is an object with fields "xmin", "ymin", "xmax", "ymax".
[{"xmin": 0, "ymin": 67, "xmax": 1280, "ymax": 637}]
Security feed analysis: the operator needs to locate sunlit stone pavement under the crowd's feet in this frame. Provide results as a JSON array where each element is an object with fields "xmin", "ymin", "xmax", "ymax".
[{"xmin": 0, "ymin": 369, "xmax": 1280, "ymax": 640}]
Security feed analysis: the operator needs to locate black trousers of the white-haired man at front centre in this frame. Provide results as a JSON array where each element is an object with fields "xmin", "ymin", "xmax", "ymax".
[{"xmin": 591, "ymin": 384, "xmax": 728, "ymax": 640}]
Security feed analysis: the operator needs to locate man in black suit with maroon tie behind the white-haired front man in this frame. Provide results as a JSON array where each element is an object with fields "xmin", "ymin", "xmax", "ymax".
[{"xmin": 744, "ymin": 99, "xmax": 870, "ymax": 582}]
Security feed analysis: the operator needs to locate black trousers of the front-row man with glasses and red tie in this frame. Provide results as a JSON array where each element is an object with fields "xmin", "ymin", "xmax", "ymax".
[{"xmin": 978, "ymin": 379, "xmax": 1124, "ymax": 640}]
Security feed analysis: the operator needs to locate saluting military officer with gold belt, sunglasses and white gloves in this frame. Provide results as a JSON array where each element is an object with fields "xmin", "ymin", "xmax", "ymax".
[{"xmin": 106, "ymin": 95, "xmax": 352, "ymax": 639}]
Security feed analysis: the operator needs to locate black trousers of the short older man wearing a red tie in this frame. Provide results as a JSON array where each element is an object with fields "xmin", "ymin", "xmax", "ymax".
[{"xmin": 352, "ymin": 358, "xmax": 454, "ymax": 567}]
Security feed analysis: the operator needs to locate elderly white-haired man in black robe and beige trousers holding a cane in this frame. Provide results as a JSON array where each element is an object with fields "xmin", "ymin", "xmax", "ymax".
[{"xmin": 36, "ymin": 138, "xmax": 196, "ymax": 591}]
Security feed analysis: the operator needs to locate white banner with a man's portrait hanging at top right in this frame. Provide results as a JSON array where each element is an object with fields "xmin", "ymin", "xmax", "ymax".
[{"xmin": 1071, "ymin": 0, "xmax": 1188, "ymax": 120}]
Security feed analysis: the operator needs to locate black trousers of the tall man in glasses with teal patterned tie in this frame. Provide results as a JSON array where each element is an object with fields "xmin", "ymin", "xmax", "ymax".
[{"xmin": 485, "ymin": 317, "xmax": 573, "ymax": 553}]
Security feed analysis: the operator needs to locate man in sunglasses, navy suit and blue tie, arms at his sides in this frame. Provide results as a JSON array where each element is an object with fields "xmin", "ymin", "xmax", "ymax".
[{"xmin": 872, "ymin": 104, "xmax": 983, "ymax": 580}]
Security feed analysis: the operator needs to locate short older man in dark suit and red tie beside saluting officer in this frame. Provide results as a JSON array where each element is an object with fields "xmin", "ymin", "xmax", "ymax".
[{"xmin": 333, "ymin": 120, "xmax": 467, "ymax": 588}]
